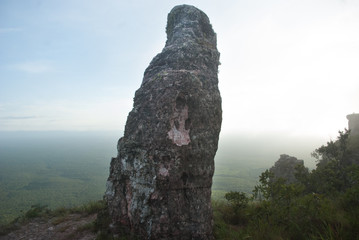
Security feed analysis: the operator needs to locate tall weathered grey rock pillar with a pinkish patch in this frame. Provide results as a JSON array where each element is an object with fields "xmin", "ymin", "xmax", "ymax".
[{"xmin": 105, "ymin": 5, "xmax": 222, "ymax": 239}]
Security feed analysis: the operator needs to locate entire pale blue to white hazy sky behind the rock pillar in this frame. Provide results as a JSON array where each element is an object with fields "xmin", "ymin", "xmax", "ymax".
[{"xmin": 0, "ymin": 0, "xmax": 359, "ymax": 138}]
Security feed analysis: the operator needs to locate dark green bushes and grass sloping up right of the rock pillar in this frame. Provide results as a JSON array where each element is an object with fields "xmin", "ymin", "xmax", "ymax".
[{"xmin": 213, "ymin": 131, "xmax": 359, "ymax": 239}]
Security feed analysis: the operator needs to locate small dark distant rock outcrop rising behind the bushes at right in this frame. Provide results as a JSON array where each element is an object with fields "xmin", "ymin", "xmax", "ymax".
[{"xmin": 269, "ymin": 154, "xmax": 304, "ymax": 184}]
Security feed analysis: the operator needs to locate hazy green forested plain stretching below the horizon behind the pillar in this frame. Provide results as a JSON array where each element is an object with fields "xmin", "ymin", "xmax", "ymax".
[{"xmin": 0, "ymin": 131, "xmax": 325, "ymax": 221}]
